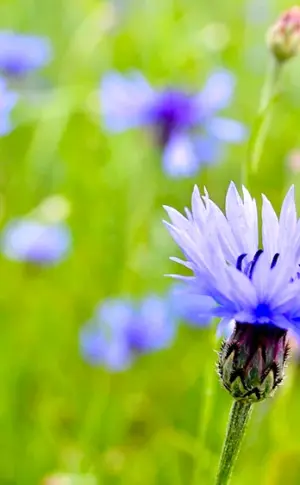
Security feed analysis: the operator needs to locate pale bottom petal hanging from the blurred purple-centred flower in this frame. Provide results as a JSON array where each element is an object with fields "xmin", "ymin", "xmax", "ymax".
[{"xmin": 163, "ymin": 133, "xmax": 200, "ymax": 178}]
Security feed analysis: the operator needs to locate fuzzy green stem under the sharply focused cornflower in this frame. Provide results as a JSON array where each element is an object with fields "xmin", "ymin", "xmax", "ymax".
[{"xmin": 216, "ymin": 401, "xmax": 252, "ymax": 485}]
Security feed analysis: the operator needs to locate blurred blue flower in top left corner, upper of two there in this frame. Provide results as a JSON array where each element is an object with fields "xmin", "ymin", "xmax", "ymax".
[{"xmin": 0, "ymin": 31, "xmax": 52, "ymax": 77}]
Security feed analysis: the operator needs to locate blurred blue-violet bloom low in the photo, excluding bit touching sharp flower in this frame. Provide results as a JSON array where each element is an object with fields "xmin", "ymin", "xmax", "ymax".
[{"xmin": 80, "ymin": 295, "xmax": 176, "ymax": 371}]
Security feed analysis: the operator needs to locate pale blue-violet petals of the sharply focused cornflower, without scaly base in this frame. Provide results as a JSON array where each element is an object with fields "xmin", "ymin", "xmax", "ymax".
[{"xmin": 166, "ymin": 183, "xmax": 300, "ymax": 334}]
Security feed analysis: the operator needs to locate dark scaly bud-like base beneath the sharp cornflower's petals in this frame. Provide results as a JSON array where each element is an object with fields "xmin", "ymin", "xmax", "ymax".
[{"xmin": 218, "ymin": 322, "xmax": 288, "ymax": 402}]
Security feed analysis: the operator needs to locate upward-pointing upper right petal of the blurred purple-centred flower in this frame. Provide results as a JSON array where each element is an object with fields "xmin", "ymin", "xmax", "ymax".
[{"xmin": 198, "ymin": 70, "xmax": 235, "ymax": 114}]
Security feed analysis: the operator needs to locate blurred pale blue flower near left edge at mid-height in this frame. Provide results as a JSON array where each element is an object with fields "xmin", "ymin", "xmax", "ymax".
[{"xmin": 1, "ymin": 218, "xmax": 71, "ymax": 265}]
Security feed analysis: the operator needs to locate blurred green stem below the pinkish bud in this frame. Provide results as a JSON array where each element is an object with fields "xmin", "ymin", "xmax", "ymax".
[{"xmin": 242, "ymin": 59, "xmax": 282, "ymax": 185}]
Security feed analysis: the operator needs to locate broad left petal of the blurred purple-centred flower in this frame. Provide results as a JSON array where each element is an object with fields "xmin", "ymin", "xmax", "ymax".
[{"xmin": 99, "ymin": 71, "xmax": 155, "ymax": 132}]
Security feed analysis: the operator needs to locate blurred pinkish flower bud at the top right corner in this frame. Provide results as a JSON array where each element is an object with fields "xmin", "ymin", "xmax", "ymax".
[{"xmin": 267, "ymin": 6, "xmax": 300, "ymax": 62}]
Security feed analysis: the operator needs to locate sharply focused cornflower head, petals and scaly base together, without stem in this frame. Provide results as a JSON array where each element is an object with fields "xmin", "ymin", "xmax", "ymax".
[{"xmin": 166, "ymin": 183, "xmax": 300, "ymax": 401}]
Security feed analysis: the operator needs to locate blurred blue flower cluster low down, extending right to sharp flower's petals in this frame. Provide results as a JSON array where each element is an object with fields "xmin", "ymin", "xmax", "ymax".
[{"xmin": 80, "ymin": 285, "xmax": 211, "ymax": 371}]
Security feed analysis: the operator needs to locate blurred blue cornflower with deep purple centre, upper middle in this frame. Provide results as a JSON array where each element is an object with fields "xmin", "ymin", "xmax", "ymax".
[{"xmin": 100, "ymin": 70, "xmax": 246, "ymax": 177}]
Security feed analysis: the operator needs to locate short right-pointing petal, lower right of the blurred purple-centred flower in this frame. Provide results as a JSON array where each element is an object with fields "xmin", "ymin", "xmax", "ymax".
[{"xmin": 205, "ymin": 117, "xmax": 247, "ymax": 143}]
